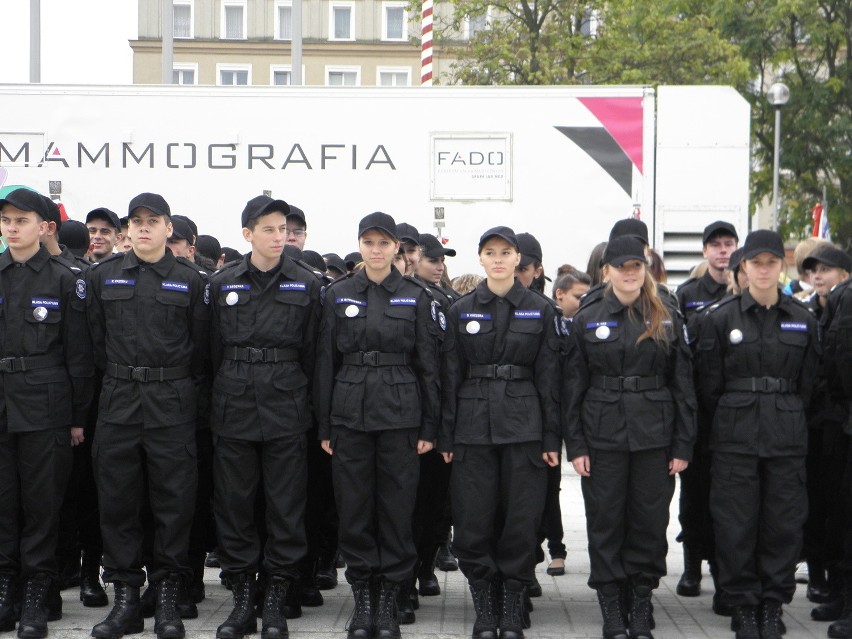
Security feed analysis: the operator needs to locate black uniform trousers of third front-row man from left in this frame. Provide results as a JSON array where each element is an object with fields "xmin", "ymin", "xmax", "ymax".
[{"xmin": 213, "ymin": 435, "xmax": 307, "ymax": 580}]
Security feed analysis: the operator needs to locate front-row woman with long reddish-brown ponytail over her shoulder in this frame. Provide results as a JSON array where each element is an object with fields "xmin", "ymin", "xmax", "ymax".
[{"xmin": 563, "ymin": 236, "xmax": 696, "ymax": 639}]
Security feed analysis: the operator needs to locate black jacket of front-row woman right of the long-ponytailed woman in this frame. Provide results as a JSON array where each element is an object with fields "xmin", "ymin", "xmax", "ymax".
[{"xmin": 695, "ymin": 290, "xmax": 820, "ymax": 457}]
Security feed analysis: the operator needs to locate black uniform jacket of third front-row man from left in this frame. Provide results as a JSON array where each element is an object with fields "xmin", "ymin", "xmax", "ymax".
[{"xmin": 210, "ymin": 254, "xmax": 322, "ymax": 441}]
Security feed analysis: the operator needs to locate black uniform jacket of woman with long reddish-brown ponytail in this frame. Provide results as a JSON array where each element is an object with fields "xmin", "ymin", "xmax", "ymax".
[{"xmin": 563, "ymin": 292, "xmax": 697, "ymax": 461}]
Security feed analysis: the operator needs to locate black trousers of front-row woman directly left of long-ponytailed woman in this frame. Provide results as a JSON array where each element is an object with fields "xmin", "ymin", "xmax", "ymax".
[{"xmin": 450, "ymin": 442, "xmax": 547, "ymax": 584}]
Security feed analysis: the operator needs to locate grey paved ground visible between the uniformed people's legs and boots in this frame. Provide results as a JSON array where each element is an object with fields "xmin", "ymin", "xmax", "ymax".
[{"xmin": 40, "ymin": 465, "xmax": 828, "ymax": 639}]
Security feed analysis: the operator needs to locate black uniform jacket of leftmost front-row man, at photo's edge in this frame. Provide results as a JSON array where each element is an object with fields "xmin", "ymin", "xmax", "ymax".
[{"xmin": 0, "ymin": 246, "xmax": 95, "ymax": 432}]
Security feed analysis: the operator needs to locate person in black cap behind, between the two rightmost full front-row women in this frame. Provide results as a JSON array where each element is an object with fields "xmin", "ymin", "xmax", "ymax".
[{"xmin": 677, "ymin": 220, "xmax": 739, "ymax": 612}]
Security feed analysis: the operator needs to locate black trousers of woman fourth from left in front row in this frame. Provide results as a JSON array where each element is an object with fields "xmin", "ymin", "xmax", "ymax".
[{"xmin": 331, "ymin": 426, "xmax": 420, "ymax": 584}]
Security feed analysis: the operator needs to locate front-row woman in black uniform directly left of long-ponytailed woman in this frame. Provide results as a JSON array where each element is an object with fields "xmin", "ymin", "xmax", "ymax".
[{"xmin": 438, "ymin": 226, "xmax": 560, "ymax": 639}]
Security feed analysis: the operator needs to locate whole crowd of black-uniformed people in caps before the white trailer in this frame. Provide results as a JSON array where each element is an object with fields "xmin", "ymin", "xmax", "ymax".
[{"xmin": 0, "ymin": 189, "xmax": 852, "ymax": 639}]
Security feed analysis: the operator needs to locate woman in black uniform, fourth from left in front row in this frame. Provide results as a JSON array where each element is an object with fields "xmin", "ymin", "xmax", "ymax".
[{"xmin": 314, "ymin": 213, "xmax": 445, "ymax": 639}]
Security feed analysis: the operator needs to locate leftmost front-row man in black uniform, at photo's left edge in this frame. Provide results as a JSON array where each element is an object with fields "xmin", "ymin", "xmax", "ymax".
[{"xmin": 0, "ymin": 188, "xmax": 94, "ymax": 639}]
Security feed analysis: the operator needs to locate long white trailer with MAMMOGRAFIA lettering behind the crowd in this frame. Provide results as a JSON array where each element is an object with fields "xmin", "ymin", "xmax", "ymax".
[{"xmin": 0, "ymin": 85, "xmax": 750, "ymax": 281}]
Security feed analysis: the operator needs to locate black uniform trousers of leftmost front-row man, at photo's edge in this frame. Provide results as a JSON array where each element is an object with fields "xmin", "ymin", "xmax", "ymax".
[{"xmin": 0, "ymin": 428, "xmax": 72, "ymax": 580}]
